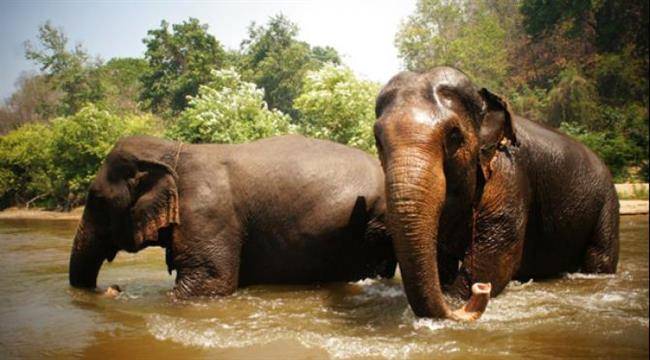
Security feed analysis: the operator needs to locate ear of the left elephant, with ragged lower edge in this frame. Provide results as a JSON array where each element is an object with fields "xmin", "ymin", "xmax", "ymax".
[{"xmin": 129, "ymin": 160, "xmax": 180, "ymax": 246}]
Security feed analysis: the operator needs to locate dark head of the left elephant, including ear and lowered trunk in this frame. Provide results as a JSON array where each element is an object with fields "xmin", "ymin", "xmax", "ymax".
[{"xmin": 69, "ymin": 137, "xmax": 179, "ymax": 288}]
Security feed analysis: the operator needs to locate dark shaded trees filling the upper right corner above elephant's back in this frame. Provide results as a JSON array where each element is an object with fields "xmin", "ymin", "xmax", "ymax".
[{"xmin": 521, "ymin": 0, "xmax": 649, "ymax": 180}]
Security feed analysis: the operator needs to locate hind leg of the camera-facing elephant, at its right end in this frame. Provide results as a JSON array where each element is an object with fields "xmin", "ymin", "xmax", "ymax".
[{"xmin": 581, "ymin": 198, "xmax": 619, "ymax": 274}]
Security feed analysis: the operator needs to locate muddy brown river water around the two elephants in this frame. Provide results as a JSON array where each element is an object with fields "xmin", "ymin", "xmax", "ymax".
[{"xmin": 0, "ymin": 216, "xmax": 648, "ymax": 359}]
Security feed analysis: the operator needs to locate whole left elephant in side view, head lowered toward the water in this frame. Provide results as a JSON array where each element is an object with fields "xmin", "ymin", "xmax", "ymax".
[{"xmin": 69, "ymin": 136, "xmax": 396, "ymax": 298}]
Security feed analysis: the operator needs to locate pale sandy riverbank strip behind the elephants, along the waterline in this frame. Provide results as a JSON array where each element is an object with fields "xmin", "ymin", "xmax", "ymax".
[{"xmin": 0, "ymin": 200, "xmax": 650, "ymax": 220}]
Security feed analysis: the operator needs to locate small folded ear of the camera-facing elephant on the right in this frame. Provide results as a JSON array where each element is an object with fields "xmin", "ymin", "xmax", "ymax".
[{"xmin": 479, "ymin": 88, "xmax": 518, "ymax": 180}]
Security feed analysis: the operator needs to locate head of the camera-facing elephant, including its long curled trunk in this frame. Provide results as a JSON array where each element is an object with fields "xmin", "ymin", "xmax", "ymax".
[{"xmin": 374, "ymin": 67, "xmax": 516, "ymax": 319}]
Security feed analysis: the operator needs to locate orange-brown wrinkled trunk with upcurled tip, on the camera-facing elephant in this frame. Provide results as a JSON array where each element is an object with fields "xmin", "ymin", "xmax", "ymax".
[{"xmin": 386, "ymin": 151, "xmax": 490, "ymax": 320}]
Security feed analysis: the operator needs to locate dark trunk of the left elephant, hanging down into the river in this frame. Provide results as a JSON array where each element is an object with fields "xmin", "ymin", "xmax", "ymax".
[{"xmin": 68, "ymin": 208, "xmax": 106, "ymax": 289}]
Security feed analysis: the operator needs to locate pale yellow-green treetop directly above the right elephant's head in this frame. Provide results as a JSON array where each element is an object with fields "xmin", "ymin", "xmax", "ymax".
[{"xmin": 395, "ymin": 0, "xmax": 509, "ymax": 92}]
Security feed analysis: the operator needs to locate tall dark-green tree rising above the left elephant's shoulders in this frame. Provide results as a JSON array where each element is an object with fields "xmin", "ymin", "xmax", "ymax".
[{"xmin": 140, "ymin": 18, "xmax": 226, "ymax": 116}]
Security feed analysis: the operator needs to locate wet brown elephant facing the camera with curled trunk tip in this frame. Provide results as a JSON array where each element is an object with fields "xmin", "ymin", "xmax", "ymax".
[{"xmin": 374, "ymin": 66, "xmax": 619, "ymax": 318}]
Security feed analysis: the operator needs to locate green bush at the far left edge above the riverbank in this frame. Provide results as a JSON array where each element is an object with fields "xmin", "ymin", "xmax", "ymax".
[{"xmin": 0, "ymin": 124, "xmax": 53, "ymax": 207}]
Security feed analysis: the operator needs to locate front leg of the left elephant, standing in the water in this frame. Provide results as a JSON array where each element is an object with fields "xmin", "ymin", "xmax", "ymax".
[{"xmin": 173, "ymin": 225, "xmax": 242, "ymax": 298}]
